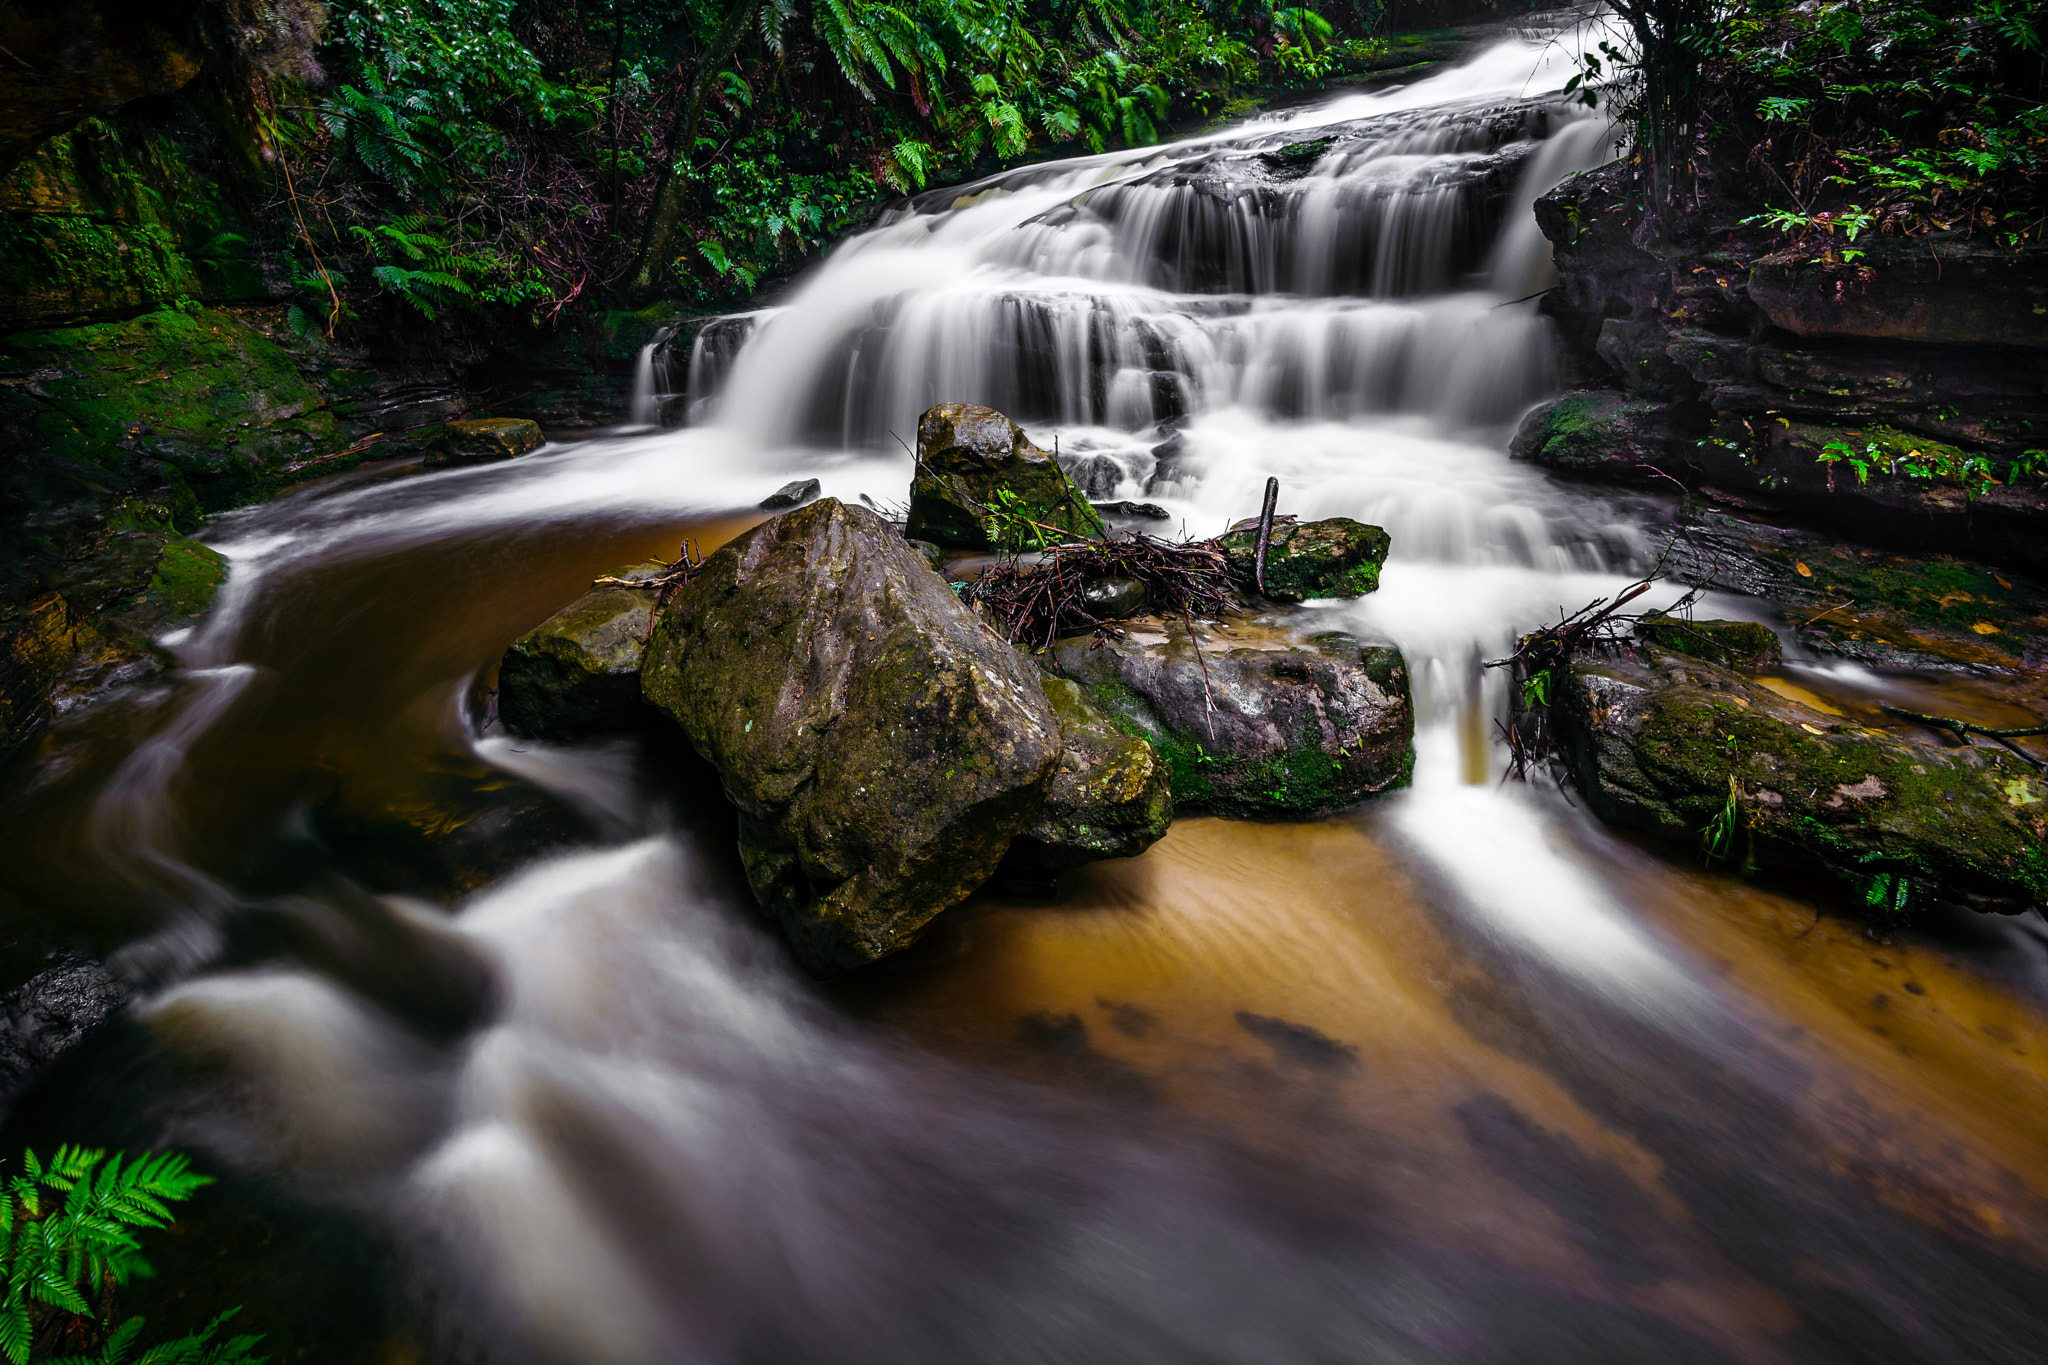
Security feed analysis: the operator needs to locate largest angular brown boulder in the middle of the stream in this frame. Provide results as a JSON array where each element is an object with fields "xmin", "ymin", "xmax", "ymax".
[{"xmin": 641, "ymin": 497, "xmax": 1061, "ymax": 974}]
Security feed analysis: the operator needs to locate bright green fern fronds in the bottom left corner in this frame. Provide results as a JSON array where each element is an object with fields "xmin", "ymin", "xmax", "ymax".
[{"xmin": 0, "ymin": 1146, "xmax": 264, "ymax": 1365}]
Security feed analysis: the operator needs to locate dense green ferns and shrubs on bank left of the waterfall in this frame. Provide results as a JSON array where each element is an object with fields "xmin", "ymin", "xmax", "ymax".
[{"xmin": 272, "ymin": 0, "xmax": 1380, "ymax": 323}]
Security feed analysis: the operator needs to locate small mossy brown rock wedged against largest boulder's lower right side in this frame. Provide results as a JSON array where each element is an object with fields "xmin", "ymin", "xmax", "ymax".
[{"xmin": 1004, "ymin": 677, "xmax": 1174, "ymax": 876}]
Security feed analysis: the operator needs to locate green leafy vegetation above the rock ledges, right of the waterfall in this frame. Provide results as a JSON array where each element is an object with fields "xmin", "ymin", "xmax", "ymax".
[{"xmin": 1583, "ymin": 0, "xmax": 2048, "ymax": 245}]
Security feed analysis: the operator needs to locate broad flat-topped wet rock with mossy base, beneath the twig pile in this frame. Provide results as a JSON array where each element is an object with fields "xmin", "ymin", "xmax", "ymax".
[{"xmin": 1053, "ymin": 618, "xmax": 1415, "ymax": 819}]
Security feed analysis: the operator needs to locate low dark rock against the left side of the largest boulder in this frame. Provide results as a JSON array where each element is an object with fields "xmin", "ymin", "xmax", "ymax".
[{"xmin": 498, "ymin": 561, "xmax": 666, "ymax": 741}]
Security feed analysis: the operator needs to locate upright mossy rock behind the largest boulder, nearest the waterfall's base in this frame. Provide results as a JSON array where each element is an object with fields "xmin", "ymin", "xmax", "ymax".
[{"xmin": 907, "ymin": 403, "xmax": 1102, "ymax": 551}]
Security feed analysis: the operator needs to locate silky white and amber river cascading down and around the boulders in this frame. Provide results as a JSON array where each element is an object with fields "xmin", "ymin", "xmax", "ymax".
[{"xmin": 4, "ymin": 13, "xmax": 2048, "ymax": 1365}]
